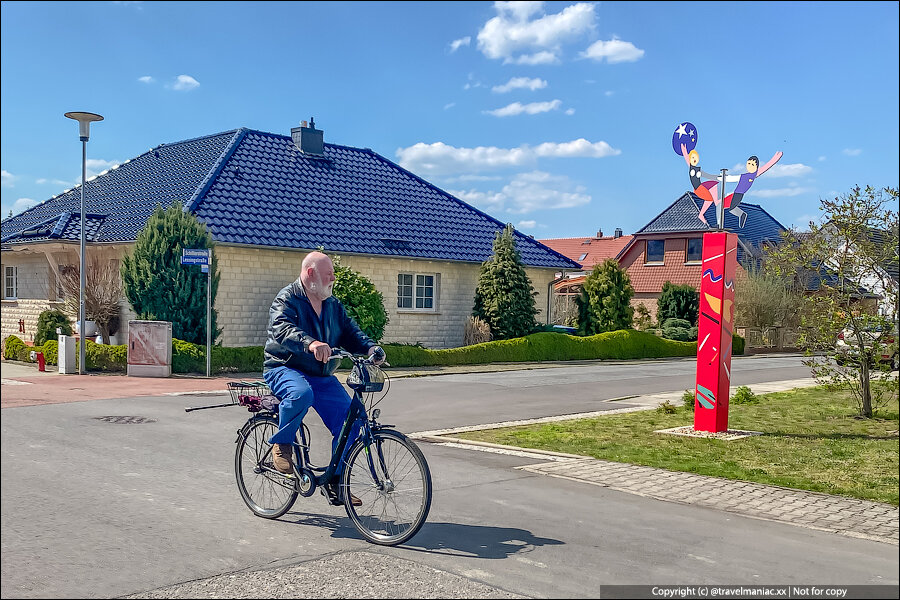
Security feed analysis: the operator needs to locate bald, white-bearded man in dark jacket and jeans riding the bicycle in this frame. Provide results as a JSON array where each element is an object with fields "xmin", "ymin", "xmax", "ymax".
[{"xmin": 263, "ymin": 252, "xmax": 385, "ymax": 506}]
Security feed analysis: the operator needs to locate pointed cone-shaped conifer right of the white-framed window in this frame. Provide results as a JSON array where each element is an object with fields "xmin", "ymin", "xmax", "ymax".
[{"xmin": 472, "ymin": 224, "xmax": 537, "ymax": 339}]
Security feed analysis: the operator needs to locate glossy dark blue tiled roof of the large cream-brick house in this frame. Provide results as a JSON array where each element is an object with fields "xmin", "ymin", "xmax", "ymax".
[{"xmin": 2, "ymin": 129, "xmax": 577, "ymax": 268}]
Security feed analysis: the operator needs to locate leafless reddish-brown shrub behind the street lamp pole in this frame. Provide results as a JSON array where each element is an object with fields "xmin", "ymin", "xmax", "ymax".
[{"xmin": 60, "ymin": 256, "xmax": 122, "ymax": 344}]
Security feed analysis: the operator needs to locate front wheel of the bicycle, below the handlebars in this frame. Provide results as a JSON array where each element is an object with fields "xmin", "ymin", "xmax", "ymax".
[{"xmin": 341, "ymin": 429, "xmax": 431, "ymax": 546}]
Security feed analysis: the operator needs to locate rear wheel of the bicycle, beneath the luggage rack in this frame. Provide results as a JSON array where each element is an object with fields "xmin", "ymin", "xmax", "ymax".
[{"xmin": 234, "ymin": 417, "xmax": 299, "ymax": 519}]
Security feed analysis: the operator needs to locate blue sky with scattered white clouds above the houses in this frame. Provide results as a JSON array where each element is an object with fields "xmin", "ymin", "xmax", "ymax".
[{"xmin": 0, "ymin": 2, "xmax": 900, "ymax": 239}]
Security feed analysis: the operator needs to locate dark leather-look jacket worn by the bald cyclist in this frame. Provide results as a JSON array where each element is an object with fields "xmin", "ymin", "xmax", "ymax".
[{"xmin": 263, "ymin": 281, "xmax": 375, "ymax": 377}]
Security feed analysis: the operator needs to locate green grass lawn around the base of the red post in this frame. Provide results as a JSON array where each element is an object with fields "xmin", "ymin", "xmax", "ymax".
[{"xmin": 457, "ymin": 387, "xmax": 900, "ymax": 506}]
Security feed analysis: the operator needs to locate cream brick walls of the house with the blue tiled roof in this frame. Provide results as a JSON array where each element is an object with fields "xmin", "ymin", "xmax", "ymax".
[{"xmin": 2, "ymin": 245, "xmax": 554, "ymax": 348}]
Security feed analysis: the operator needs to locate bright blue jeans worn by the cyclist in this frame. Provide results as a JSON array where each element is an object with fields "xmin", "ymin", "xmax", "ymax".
[{"xmin": 263, "ymin": 367, "xmax": 362, "ymax": 473}]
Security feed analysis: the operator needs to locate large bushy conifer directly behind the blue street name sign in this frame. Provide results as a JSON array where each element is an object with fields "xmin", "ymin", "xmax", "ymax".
[{"xmin": 122, "ymin": 202, "xmax": 221, "ymax": 344}]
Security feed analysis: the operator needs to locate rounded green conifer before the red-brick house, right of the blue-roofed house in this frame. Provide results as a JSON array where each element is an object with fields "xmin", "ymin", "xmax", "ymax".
[{"xmin": 576, "ymin": 259, "xmax": 634, "ymax": 335}]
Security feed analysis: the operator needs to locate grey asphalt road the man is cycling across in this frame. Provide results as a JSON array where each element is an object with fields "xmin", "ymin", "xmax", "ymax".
[{"xmin": 0, "ymin": 357, "xmax": 898, "ymax": 598}]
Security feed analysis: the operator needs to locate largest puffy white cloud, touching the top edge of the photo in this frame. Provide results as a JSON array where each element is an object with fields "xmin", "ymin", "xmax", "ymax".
[{"xmin": 478, "ymin": 2, "xmax": 596, "ymax": 64}]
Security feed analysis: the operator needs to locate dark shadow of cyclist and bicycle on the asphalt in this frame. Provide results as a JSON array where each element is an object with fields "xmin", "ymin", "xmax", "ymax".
[{"xmin": 289, "ymin": 513, "xmax": 565, "ymax": 559}]
